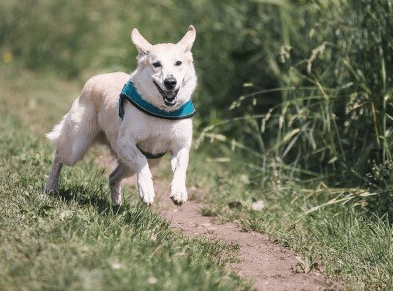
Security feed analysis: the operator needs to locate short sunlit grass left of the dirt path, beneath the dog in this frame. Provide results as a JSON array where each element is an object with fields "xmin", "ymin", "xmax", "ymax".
[{"xmin": 0, "ymin": 66, "xmax": 249, "ymax": 290}]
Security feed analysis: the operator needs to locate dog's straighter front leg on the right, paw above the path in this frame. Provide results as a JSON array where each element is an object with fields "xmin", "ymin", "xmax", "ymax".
[{"xmin": 171, "ymin": 148, "xmax": 190, "ymax": 205}]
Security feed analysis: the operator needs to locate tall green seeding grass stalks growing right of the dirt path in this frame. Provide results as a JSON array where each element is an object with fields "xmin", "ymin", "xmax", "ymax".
[{"xmin": 201, "ymin": 0, "xmax": 393, "ymax": 217}]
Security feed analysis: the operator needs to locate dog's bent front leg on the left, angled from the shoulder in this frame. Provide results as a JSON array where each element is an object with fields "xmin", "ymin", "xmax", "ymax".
[{"xmin": 116, "ymin": 134, "xmax": 155, "ymax": 205}]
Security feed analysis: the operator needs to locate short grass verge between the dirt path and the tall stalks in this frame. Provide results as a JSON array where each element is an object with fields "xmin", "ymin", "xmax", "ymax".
[{"xmin": 194, "ymin": 160, "xmax": 393, "ymax": 290}]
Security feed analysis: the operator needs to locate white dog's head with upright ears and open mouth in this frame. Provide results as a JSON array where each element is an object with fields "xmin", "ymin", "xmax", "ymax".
[{"xmin": 131, "ymin": 25, "xmax": 197, "ymax": 111}]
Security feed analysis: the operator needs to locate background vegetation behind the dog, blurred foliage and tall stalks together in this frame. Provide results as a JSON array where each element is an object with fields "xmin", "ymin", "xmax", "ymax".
[{"xmin": 0, "ymin": 0, "xmax": 393, "ymax": 217}]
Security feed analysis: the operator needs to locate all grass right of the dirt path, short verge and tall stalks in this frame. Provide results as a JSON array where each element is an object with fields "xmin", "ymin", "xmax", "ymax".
[{"xmin": 190, "ymin": 0, "xmax": 393, "ymax": 290}]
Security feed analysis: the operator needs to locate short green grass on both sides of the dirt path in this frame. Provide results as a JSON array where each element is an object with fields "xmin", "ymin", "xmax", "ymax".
[{"xmin": 0, "ymin": 65, "xmax": 393, "ymax": 290}]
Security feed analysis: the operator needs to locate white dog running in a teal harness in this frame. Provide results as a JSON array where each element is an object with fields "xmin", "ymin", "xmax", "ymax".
[{"xmin": 44, "ymin": 25, "xmax": 197, "ymax": 205}]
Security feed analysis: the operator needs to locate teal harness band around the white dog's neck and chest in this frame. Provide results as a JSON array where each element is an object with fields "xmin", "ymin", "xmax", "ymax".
[{"xmin": 119, "ymin": 80, "xmax": 196, "ymax": 120}]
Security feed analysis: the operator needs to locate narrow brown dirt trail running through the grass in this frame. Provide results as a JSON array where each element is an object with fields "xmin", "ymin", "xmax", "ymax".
[{"xmin": 100, "ymin": 157, "xmax": 342, "ymax": 291}]
